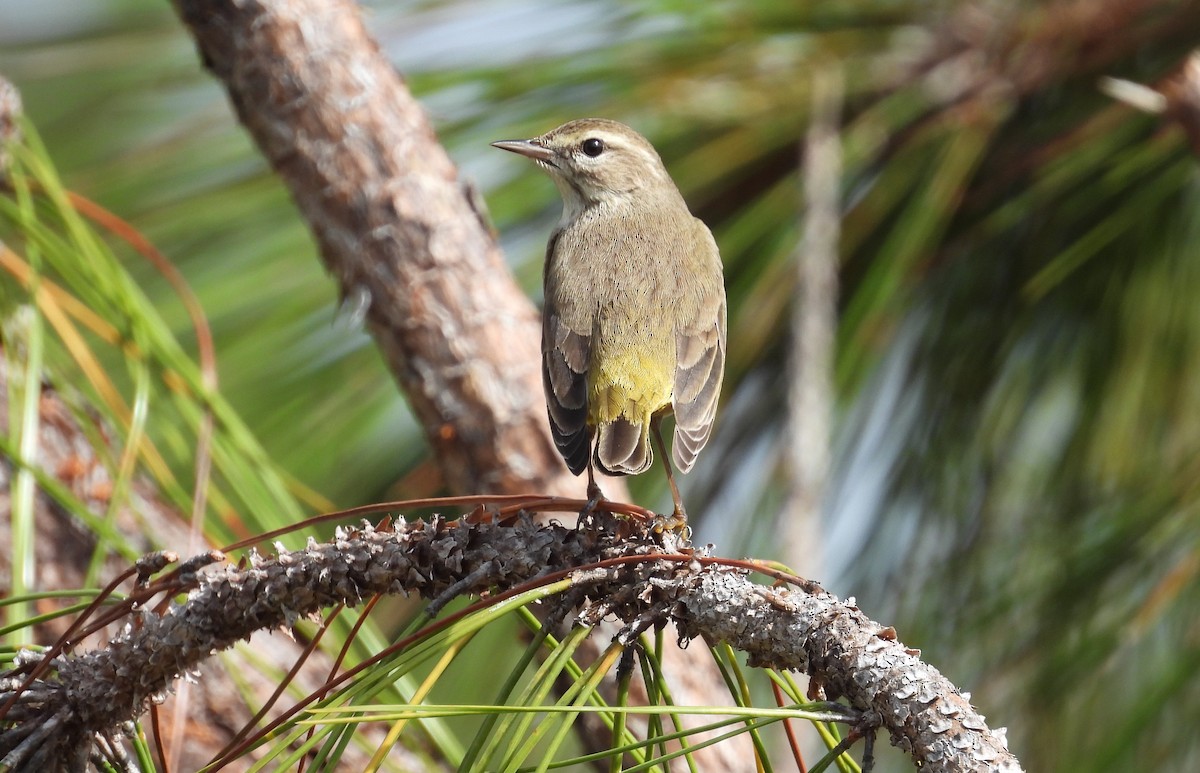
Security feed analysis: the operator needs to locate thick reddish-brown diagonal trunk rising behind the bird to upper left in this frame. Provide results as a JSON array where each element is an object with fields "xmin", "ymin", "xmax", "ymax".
[{"xmin": 175, "ymin": 0, "xmax": 571, "ymax": 496}]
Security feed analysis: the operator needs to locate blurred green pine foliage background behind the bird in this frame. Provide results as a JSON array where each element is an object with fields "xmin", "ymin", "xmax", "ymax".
[{"xmin": 0, "ymin": 0, "xmax": 1200, "ymax": 771}]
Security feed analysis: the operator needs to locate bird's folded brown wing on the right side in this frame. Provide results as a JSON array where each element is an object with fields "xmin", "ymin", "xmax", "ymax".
[{"xmin": 671, "ymin": 226, "xmax": 726, "ymax": 473}]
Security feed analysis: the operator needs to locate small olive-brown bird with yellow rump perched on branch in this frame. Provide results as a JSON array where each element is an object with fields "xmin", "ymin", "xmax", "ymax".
[{"xmin": 492, "ymin": 118, "xmax": 726, "ymax": 517}]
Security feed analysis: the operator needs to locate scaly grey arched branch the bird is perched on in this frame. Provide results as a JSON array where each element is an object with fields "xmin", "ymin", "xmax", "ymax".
[{"xmin": 0, "ymin": 519, "xmax": 1020, "ymax": 772}]
